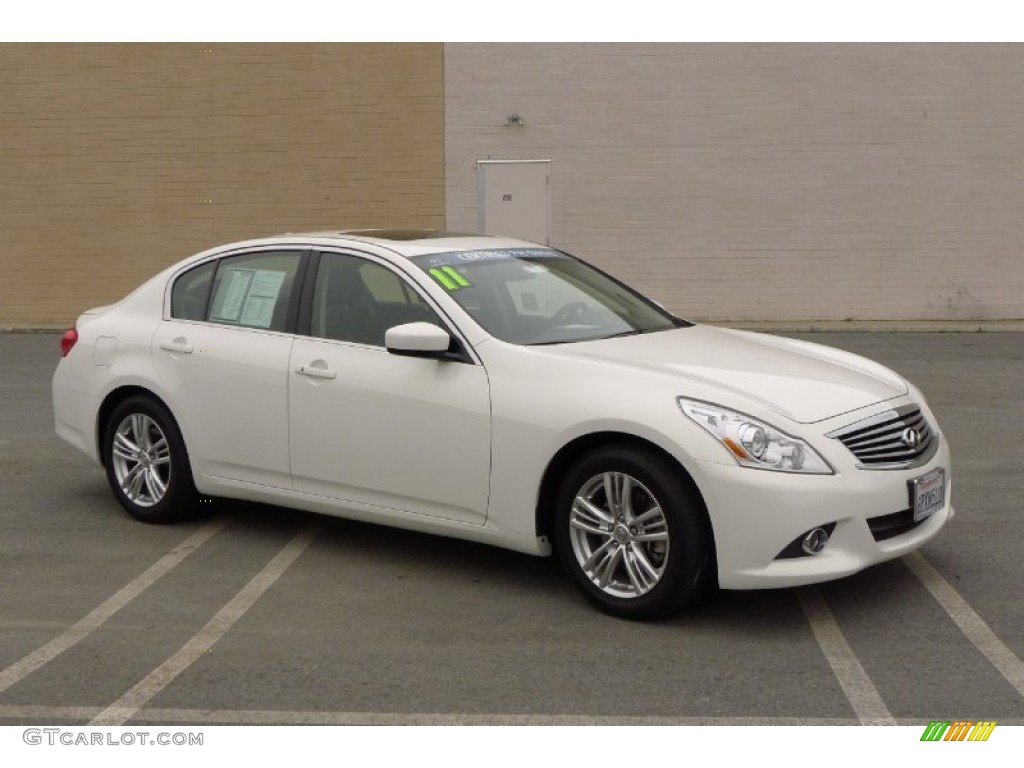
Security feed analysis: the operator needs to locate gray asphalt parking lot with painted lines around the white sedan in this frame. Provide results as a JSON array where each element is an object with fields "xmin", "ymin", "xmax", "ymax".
[{"xmin": 0, "ymin": 333, "xmax": 1024, "ymax": 725}]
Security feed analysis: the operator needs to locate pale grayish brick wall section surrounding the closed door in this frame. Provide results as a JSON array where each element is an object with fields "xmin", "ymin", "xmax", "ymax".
[{"xmin": 444, "ymin": 43, "xmax": 1024, "ymax": 319}]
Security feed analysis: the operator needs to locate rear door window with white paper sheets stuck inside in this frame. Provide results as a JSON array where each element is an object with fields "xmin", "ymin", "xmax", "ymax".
[{"xmin": 205, "ymin": 251, "xmax": 301, "ymax": 331}]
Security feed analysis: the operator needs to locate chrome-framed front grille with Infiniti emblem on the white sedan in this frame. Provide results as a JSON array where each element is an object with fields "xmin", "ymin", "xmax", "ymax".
[{"xmin": 827, "ymin": 404, "xmax": 939, "ymax": 469}]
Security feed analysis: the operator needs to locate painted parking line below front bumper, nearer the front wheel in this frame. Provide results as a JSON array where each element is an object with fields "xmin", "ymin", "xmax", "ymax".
[{"xmin": 797, "ymin": 587, "xmax": 896, "ymax": 725}]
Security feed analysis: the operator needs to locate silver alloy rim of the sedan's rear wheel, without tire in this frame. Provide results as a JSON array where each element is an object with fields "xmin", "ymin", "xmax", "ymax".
[{"xmin": 113, "ymin": 413, "xmax": 171, "ymax": 507}]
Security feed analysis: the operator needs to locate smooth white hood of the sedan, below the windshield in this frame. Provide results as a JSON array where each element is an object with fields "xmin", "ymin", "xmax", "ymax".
[{"xmin": 559, "ymin": 326, "xmax": 907, "ymax": 423}]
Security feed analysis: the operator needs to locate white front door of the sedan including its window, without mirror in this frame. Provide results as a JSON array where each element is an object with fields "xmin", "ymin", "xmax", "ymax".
[{"xmin": 289, "ymin": 253, "xmax": 490, "ymax": 523}]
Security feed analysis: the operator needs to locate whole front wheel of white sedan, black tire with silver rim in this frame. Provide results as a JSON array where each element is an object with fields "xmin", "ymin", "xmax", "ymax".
[{"xmin": 554, "ymin": 444, "xmax": 715, "ymax": 620}]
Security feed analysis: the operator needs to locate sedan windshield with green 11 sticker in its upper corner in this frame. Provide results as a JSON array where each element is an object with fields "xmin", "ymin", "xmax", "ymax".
[{"xmin": 412, "ymin": 248, "xmax": 689, "ymax": 344}]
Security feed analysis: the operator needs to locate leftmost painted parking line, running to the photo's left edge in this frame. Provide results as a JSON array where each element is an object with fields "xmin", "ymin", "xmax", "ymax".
[{"xmin": 0, "ymin": 520, "xmax": 226, "ymax": 692}]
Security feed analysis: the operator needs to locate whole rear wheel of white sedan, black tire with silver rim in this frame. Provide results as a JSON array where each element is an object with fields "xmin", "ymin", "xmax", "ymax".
[{"xmin": 102, "ymin": 395, "xmax": 198, "ymax": 523}]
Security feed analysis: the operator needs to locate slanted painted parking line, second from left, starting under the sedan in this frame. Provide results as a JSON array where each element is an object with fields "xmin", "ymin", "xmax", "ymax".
[{"xmin": 89, "ymin": 524, "xmax": 324, "ymax": 725}]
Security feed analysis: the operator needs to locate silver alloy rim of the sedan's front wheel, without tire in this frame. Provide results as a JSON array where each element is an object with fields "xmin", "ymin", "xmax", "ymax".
[{"xmin": 569, "ymin": 472, "xmax": 669, "ymax": 597}]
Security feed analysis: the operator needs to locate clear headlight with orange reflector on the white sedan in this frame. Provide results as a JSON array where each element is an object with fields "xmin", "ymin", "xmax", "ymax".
[{"xmin": 679, "ymin": 397, "xmax": 833, "ymax": 475}]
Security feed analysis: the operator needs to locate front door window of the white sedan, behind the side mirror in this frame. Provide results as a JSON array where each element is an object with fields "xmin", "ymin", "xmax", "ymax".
[{"xmin": 311, "ymin": 253, "xmax": 444, "ymax": 347}]
